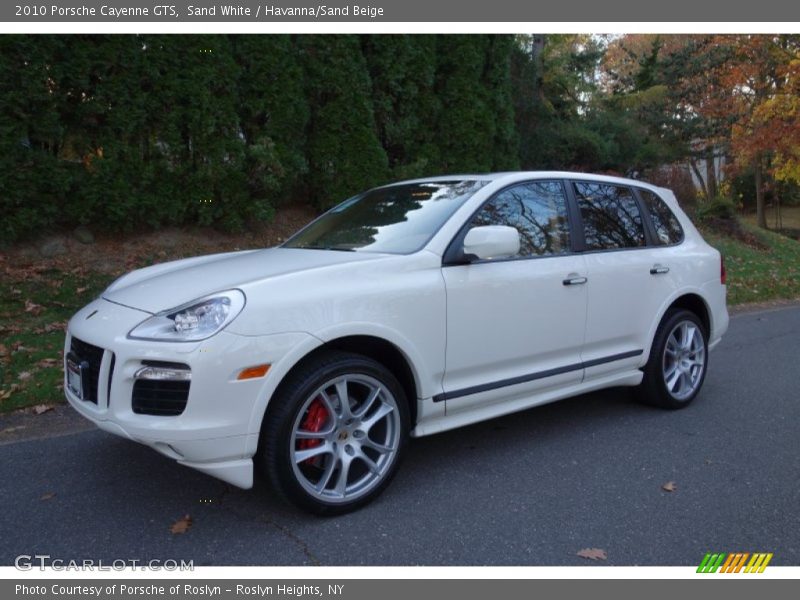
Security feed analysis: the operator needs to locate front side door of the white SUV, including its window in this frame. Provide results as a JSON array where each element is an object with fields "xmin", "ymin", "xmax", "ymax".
[{"xmin": 438, "ymin": 181, "xmax": 587, "ymax": 414}]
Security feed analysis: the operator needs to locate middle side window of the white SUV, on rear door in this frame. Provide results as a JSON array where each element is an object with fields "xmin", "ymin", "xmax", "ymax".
[{"xmin": 574, "ymin": 181, "xmax": 647, "ymax": 250}]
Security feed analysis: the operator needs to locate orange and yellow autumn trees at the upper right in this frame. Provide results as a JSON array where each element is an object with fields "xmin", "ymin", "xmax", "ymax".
[{"xmin": 603, "ymin": 35, "xmax": 800, "ymax": 228}]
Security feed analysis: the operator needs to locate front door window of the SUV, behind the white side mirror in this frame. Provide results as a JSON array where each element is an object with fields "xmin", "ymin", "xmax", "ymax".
[{"xmin": 470, "ymin": 181, "xmax": 570, "ymax": 257}]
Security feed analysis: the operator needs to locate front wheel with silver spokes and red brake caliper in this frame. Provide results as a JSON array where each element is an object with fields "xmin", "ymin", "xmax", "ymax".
[{"xmin": 257, "ymin": 351, "xmax": 409, "ymax": 515}]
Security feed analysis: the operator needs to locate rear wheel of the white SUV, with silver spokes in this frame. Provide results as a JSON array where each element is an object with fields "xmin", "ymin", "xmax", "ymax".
[{"xmin": 637, "ymin": 309, "xmax": 708, "ymax": 410}]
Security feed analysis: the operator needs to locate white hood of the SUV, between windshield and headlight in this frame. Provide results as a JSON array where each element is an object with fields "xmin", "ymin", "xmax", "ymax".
[{"xmin": 102, "ymin": 248, "xmax": 386, "ymax": 314}]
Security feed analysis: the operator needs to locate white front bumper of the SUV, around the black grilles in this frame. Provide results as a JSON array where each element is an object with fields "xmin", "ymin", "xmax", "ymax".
[{"xmin": 64, "ymin": 299, "xmax": 313, "ymax": 488}]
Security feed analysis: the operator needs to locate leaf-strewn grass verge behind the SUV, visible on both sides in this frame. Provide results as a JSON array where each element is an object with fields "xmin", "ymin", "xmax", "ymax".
[{"xmin": 0, "ymin": 214, "xmax": 800, "ymax": 412}]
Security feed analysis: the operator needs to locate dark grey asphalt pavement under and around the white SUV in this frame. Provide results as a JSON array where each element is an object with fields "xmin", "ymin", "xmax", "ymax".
[{"xmin": 0, "ymin": 306, "xmax": 800, "ymax": 566}]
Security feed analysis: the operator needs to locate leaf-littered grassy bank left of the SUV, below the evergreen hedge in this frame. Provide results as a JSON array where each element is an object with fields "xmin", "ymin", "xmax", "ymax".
[{"xmin": 0, "ymin": 207, "xmax": 315, "ymax": 413}]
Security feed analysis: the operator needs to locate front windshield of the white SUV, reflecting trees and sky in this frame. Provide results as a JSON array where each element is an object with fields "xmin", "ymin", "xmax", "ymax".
[{"xmin": 284, "ymin": 180, "xmax": 487, "ymax": 254}]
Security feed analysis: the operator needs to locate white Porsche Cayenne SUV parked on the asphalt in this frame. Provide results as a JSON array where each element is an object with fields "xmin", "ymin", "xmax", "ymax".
[{"xmin": 64, "ymin": 172, "xmax": 728, "ymax": 514}]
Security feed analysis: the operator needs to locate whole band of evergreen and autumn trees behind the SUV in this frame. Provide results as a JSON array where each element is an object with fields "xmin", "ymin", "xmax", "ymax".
[{"xmin": 0, "ymin": 34, "xmax": 800, "ymax": 243}]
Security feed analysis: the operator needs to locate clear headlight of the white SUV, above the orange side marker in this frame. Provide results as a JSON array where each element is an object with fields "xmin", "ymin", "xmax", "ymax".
[{"xmin": 128, "ymin": 290, "xmax": 245, "ymax": 342}]
